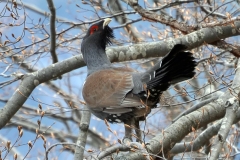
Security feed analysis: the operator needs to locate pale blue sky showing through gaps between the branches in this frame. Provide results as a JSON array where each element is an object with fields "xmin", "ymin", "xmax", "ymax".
[{"xmin": 0, "ymin": 0, "xmax": 239, "ymax": 160}]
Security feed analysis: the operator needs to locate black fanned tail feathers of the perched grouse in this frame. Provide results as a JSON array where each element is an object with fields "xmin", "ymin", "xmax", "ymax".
[{"xmin": 147, "ymin": 44, "xmax": 197, "ymax": 99}]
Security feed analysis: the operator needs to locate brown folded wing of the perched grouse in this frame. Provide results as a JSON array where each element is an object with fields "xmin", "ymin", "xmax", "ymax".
[{"xmin": 83, "ymin": 68, "xmax": 141, "ymax": 112}]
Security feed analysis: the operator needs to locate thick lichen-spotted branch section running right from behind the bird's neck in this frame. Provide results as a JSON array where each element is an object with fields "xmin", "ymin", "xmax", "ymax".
[{"xmin": 107, "ymin": 21, "xmax": 240, "ymax": 62}]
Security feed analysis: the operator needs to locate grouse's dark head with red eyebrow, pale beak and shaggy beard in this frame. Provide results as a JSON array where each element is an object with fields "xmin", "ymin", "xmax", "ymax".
[{"xmin": 82, "ymin": 18, "xmax": 114, "ymax": 51}]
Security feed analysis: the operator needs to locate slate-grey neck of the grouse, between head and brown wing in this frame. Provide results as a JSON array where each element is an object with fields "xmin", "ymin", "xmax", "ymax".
[{"xmin": 83, "ymin": 46, "xmax": 111, "ymax": 74}]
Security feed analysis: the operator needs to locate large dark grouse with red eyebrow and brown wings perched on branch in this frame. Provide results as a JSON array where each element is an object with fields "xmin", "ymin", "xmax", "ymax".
[{"xmin": 81, "ymin": 18, "xmax": 197, "ymax": 142}]
